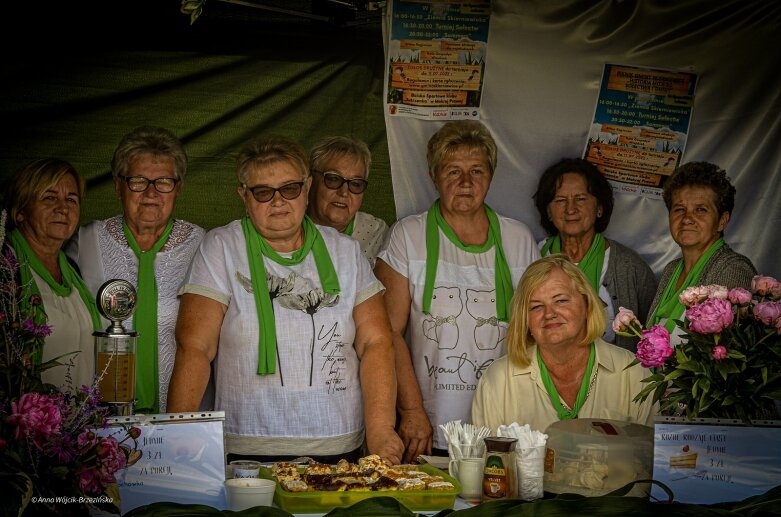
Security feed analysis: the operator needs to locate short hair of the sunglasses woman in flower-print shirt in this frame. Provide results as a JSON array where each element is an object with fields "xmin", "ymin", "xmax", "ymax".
[{"xmin": 236, "ymin": 135, "xmax": 309, "ymax": 184}]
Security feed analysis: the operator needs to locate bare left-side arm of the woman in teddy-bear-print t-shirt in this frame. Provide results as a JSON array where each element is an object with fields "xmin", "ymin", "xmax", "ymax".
[{"xmin": 374, "ymin": 259, "xmax": 433, "ymax": 463}]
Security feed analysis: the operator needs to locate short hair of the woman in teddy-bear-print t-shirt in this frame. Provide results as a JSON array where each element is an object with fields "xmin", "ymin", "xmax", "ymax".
[{"xmin": 426, "ymin": 120, "xmax": 496, "ymax": 178}]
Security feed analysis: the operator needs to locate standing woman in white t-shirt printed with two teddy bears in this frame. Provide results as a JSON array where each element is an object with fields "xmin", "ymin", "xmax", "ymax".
[{"xmin": 375, "ymin": 120, "xmax": 540, "ymax": 462}]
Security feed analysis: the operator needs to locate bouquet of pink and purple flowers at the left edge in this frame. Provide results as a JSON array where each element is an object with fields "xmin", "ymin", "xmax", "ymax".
[{"xmin": 0, "ymin": 211, "xmax": 140, "ymax": 515}]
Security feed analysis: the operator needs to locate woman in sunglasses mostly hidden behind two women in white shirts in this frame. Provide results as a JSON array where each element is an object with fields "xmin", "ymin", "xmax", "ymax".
[{"xmin": 307, "ymin": 136, "xmax": 388, "ymax": 267}]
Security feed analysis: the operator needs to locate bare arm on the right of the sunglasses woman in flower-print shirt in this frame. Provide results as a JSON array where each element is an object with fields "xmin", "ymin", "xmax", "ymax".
[{"xmin": 353, "ymin": 294, "xmax": 404, "ymax": 465}]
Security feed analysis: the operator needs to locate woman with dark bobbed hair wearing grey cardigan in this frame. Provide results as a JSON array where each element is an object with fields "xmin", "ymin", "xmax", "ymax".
[{"xmin": 534, "ymin": 158, "xmax": 656, "ymax": 352}]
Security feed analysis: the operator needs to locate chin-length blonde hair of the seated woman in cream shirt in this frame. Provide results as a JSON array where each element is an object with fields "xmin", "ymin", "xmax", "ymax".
[{"xmin": 507, "ymin": 253, "xmax": 607, "ymax": 368}]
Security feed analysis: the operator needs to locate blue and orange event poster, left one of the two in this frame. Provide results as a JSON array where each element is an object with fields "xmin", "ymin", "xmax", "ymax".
[{"xmin": 386, "ymin": 0, "xmax": 491, "ymax": 120}]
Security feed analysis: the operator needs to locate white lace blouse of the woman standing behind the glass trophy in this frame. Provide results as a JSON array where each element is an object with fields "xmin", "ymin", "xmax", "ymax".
[{"xmin": 65, "ymin": 215, "xmax": 205, "ymax": 413}]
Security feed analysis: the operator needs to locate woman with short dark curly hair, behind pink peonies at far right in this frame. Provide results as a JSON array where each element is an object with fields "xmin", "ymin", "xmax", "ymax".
[{"xmin": 646, "ymin": 162, "xmax": 757, "ymax": 336}]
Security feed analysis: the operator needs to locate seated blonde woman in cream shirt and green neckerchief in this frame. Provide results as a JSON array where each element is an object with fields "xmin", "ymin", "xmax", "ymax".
[{"xmin": 472, "ymin": 254, "xmax": 656, "ymax": 432}]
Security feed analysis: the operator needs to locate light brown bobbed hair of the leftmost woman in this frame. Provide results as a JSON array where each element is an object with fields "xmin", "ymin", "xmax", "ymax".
[{"xmin": 5, "ymin": 158, "xmax": 86, "ymax": 231}]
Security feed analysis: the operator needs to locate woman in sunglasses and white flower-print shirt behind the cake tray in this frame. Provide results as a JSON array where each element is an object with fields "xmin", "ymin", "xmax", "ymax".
[{"xmin": 168, "ymin": 137, "xmax": 402, "ymax": 463}]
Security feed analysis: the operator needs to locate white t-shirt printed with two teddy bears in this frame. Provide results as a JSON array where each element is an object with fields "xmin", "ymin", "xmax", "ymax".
[{"xmin": 377, "ymin": 212, "xmax": 540, "ymax": 449}]
